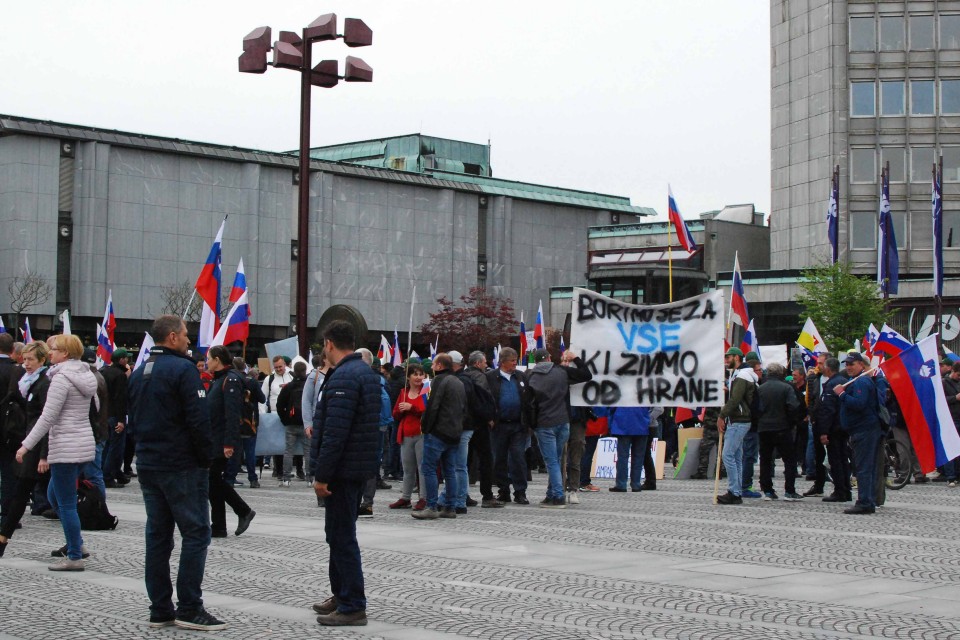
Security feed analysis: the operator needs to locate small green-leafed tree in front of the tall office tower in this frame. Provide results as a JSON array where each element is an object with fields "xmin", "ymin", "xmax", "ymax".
[{"xmin": 797, "ymin": 262, "xmax": 890, "ymax": 352}]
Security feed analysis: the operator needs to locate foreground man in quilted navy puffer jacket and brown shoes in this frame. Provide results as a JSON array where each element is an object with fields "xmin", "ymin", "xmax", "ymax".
[{"xmin": 310, "ymin": 320, "xmax": 380, "ymax": 626}]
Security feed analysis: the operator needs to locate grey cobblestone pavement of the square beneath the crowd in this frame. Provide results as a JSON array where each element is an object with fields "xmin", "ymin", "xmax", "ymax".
[{"xmin": 0, "ymin": 475, "xmax": 960, "ymax": 640}]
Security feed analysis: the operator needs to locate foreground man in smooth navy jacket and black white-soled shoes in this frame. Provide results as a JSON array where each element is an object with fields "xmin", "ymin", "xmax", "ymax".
[{"xmin": 127, "ymin": 315, "xmax": 220, "ymax": 630}]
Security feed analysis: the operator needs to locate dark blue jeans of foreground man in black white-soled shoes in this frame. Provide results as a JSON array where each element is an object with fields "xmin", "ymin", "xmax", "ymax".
[{"xmin": 138, "ymin": 468, "xmax": 210, "ymax": 617}]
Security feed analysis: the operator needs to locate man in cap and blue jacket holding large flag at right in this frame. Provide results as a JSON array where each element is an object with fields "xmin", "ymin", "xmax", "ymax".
[{"xmin": 833, "ymin": 352, "xmax": 883, "ymax": 515}]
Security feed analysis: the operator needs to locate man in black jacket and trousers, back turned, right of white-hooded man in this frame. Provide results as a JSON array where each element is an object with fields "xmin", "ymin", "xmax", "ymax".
[{"xmin": 757, "ymin": 363, "xmax": 803, "ymax": 502}]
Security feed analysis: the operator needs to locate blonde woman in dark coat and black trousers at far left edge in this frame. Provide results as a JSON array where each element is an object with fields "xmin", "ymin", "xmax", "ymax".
[{"xmin": 0, "ymin": 340, "xmax": 50, "ymax": 556}]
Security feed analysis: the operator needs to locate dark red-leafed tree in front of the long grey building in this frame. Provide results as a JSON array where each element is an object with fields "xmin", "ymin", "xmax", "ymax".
[{"xmin": 420, "ymin": 287, "xmax": 519, "ymax": 356}]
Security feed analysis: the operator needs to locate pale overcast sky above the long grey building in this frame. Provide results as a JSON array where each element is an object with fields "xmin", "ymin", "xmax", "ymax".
[{"xmin": 0, "ymin": 0, "xmax": 770, "ymax": 218}]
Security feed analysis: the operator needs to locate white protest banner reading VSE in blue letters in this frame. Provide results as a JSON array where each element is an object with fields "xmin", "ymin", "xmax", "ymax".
[{"xmin": 570, "ymin": 288, "xmax": 724, "ymax": 409}]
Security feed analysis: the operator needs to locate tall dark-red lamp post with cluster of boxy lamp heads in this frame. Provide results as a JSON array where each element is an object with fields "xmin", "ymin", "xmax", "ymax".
[{"xmin": 239, "ymin": 13, "xmax": 373, "ymax": 355}]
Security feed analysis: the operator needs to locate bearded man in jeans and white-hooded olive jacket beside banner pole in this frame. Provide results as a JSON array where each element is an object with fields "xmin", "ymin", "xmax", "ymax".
[{"xmin": 717, "ymin": 347, "xmax": 758, "ymax": 504}]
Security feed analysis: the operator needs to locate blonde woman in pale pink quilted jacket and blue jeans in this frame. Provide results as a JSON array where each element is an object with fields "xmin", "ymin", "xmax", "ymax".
[{"xmin": 16, "ymin": 335, "xmax": 99, "ymax": 571}]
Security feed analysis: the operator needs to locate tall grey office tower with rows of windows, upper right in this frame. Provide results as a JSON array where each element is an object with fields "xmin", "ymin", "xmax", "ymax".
[{"xmin": 770, "ymin": 0, "xmax": 960, "ymax": 290}]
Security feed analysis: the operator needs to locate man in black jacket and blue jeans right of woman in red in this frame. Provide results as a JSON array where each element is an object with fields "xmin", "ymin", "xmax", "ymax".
[{"xmin": 412, "ymin": 353, "xmax": 467, "ymax": 520}]
